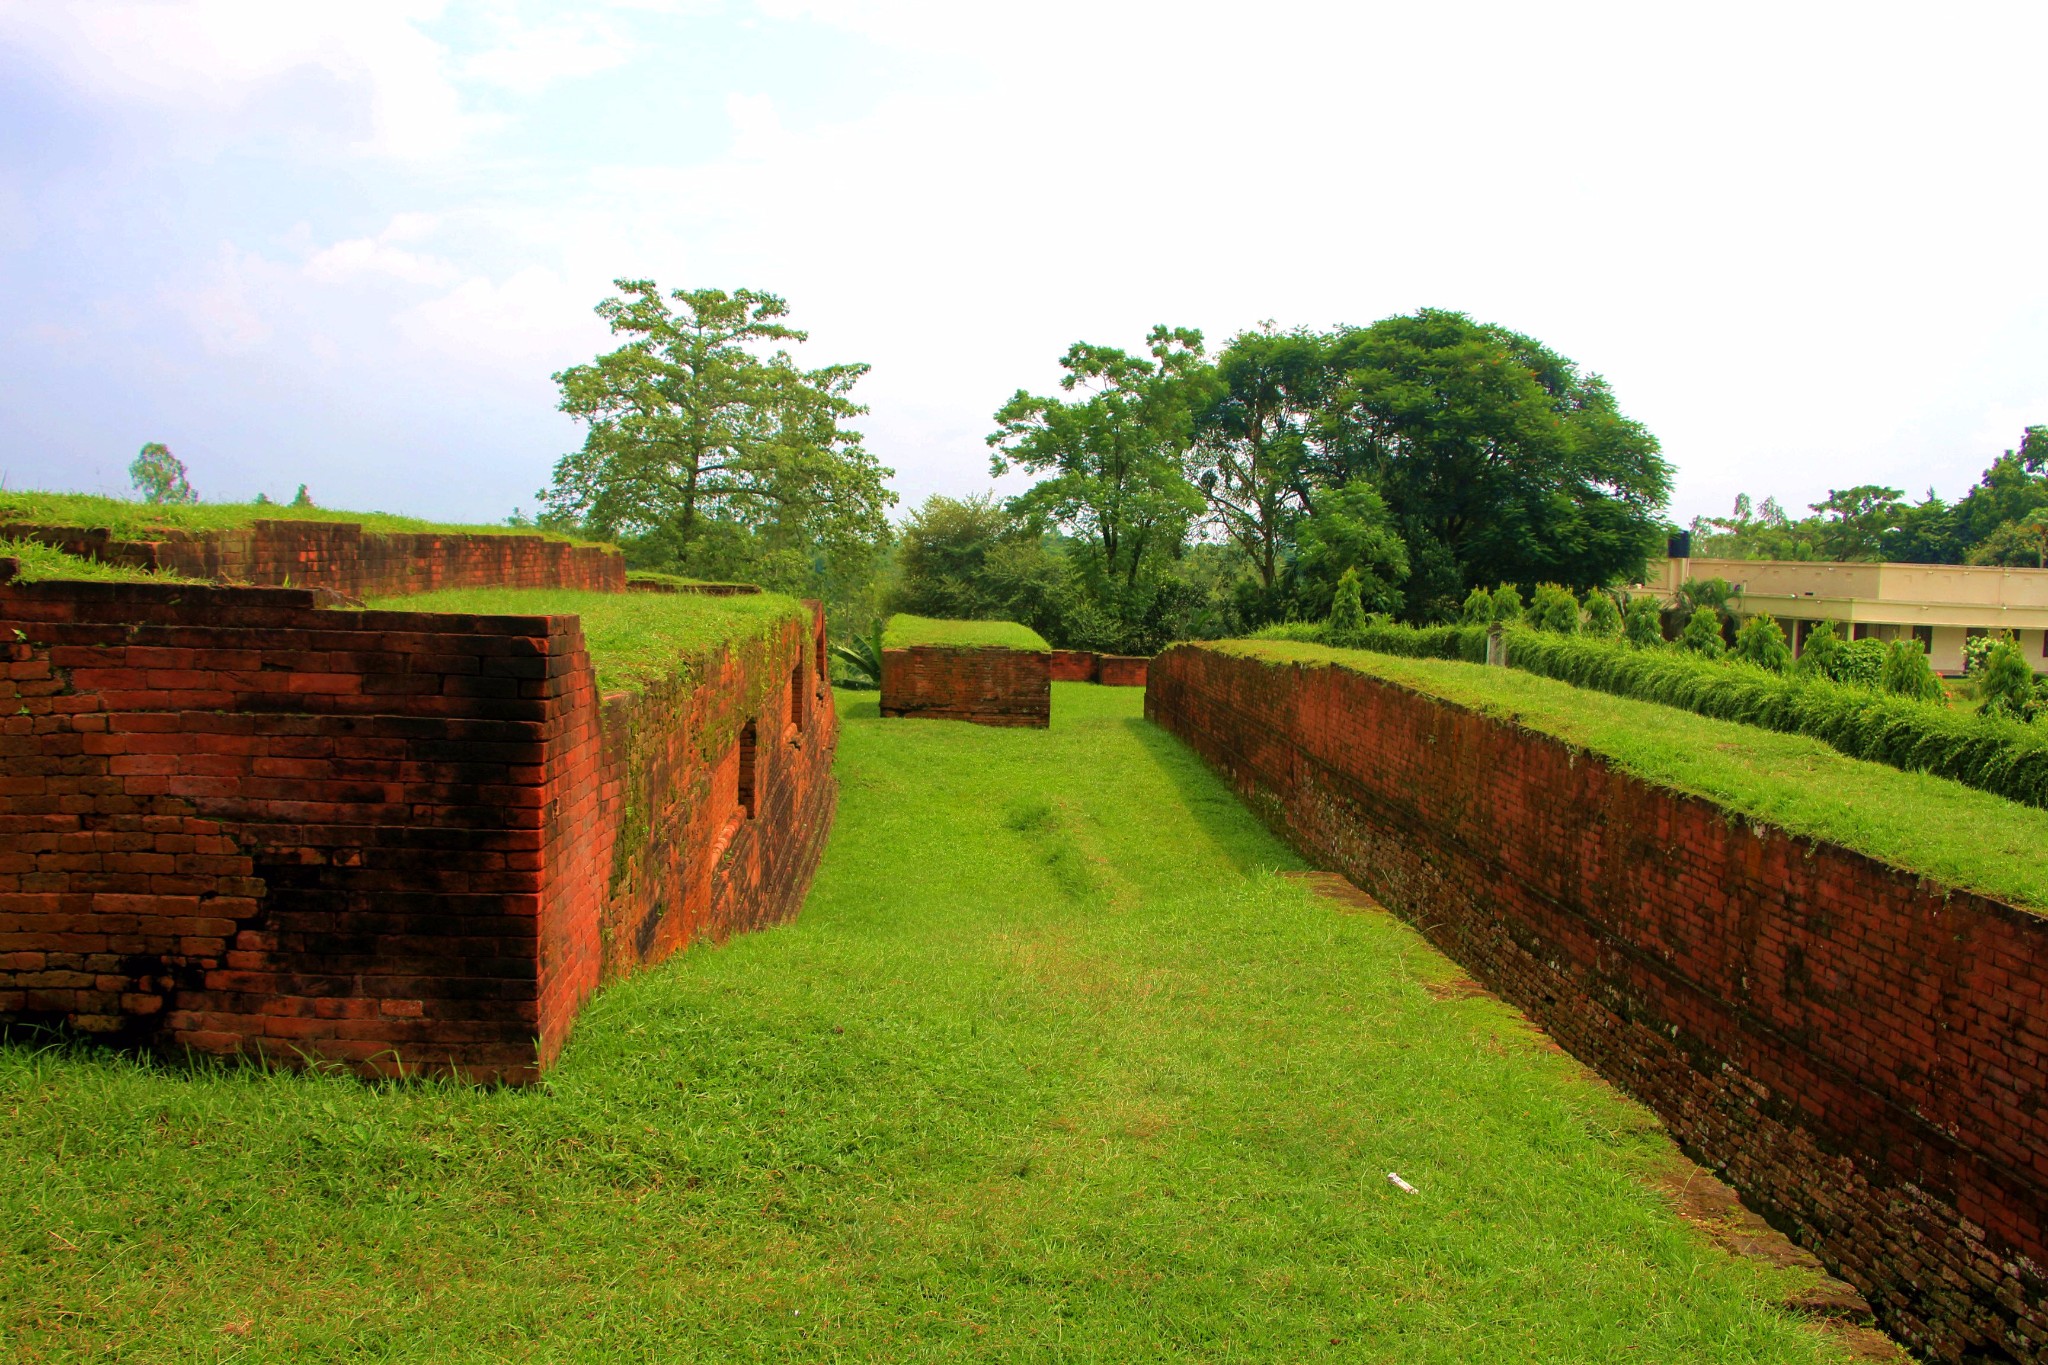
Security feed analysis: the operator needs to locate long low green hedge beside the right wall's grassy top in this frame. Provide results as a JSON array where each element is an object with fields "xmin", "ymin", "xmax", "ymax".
[{"xmin": 1236, "ymin": 624, "xmax": 2048, "ymax": 806}]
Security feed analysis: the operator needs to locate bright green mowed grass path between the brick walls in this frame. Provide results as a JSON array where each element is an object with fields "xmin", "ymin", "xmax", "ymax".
[{"xmin": 0, "ymin": 684, "xmax": 1859, "ymax": 1363}]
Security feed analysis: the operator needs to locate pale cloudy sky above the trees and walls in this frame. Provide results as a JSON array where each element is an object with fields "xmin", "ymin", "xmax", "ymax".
[{"xmin": 0, "ymin": 0, "xmax": 2048, "ymax": 522}]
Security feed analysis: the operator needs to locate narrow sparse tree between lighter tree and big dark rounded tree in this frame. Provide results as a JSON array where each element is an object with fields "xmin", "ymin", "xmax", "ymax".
[{"xmin": 1188, "ymin": 329, "xmax": 1318, "ymax": 596}]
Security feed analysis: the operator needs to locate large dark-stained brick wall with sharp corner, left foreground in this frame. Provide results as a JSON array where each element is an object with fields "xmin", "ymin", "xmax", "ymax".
[{"xmin": 0, "ymin": 583, "xmax": 834, "ymax": 1081}]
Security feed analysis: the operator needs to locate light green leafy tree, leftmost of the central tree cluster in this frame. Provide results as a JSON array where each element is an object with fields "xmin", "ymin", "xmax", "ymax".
[{"xmin": 989, "ymin": 325, "xmax": 1212, "ymax": 587}]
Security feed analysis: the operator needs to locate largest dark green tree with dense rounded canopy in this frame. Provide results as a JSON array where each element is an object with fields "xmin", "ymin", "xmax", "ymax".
[{"xmin": 1317, "ymin": 309, "xmax": 1671, "ymax": 618}]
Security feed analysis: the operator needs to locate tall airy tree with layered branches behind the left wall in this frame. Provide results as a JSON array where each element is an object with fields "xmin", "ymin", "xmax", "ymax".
[{"xmin": 541, "ymin": 278, "xmax": 895, "ymax": 567}]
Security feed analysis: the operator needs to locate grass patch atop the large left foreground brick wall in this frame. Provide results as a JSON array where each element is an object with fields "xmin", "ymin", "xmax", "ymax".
[{"xmin": 367, "ymin": 587, "xmax": 809, "ymax": 692}]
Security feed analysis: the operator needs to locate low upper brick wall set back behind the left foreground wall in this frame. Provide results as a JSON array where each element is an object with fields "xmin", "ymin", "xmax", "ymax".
[{"xmin": 0, "ymin": 520, "xmax": 627, "ymax": 598}]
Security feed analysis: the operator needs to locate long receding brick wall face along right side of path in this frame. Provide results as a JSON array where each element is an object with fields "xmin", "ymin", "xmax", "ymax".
[{"xmin": 1145, "ymin": 647, "xmax": 2048, "ymax": 1361}]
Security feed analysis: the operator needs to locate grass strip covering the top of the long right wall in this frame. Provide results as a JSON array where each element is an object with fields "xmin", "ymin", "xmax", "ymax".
[{"xmin": 1208, "ymin": 641, "xmax": 2048, "ymax": 911}]
